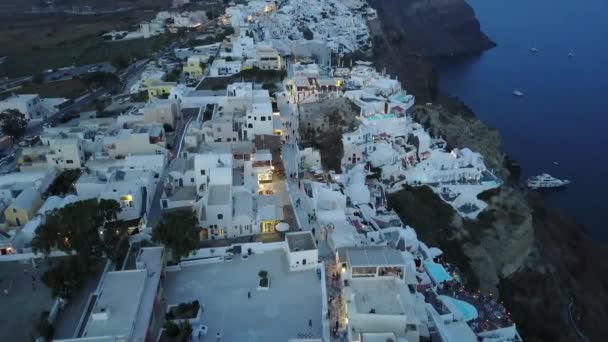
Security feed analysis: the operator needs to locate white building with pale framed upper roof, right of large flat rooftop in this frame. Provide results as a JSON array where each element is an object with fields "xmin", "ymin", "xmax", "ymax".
[{"xmin": 336, "ymin": 246, "xmax": 427, "ymax": 341}]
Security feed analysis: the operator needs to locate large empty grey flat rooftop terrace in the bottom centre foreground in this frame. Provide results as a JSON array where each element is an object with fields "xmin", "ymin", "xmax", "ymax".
[{"xmin": 164, "ymin": 251, "xmax": 322, "ymax": 342}]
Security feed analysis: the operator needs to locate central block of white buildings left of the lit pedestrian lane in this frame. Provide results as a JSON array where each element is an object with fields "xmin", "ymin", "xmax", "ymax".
[{"xmin": 161, "ymin": 83, "xmax": 283, "ymax": 239}]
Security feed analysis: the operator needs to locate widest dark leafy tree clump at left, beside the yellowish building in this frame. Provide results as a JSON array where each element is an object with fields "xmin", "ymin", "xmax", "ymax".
[{"xmin": 32, "ymin": 199, "xmax": 121, "ymax": 260}]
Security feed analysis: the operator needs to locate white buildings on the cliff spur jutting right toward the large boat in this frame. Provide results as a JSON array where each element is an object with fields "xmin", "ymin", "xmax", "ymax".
[{"xmin": 286, "ymin": 62, "xmax": 502, "ymax": 218}]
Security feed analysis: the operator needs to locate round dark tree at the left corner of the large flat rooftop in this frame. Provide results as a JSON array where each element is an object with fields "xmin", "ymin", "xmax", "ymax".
[{"xmin": 152, "ymin": 210, "xmax": 200, "ymax": 261}]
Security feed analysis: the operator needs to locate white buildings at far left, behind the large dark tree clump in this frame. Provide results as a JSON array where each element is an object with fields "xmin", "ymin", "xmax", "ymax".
[{"xmin": 0, "ymin": 100, "xmax": 182, "ymax": 254}]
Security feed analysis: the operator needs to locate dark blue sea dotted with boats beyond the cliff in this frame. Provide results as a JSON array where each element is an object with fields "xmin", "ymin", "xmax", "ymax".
[{"xmin": 438, "ymin": 0, "xmax": 608, "ymax": 241}]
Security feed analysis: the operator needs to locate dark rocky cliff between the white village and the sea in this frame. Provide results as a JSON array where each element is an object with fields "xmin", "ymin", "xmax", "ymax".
[{"xmin": 369, "ymin": 0, "xmax": 608, "ymax": 341}]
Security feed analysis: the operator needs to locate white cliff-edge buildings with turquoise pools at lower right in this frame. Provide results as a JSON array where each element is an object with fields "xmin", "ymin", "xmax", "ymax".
[{"xmin": 290, "ymin": 160, "xmax": 521, "ymax": 341}]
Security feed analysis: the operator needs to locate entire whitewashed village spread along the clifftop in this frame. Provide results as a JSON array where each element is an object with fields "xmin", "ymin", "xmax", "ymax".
[{"xmin": 0, "ymin": 0, "xmax": 522, "ymax": 342}]
